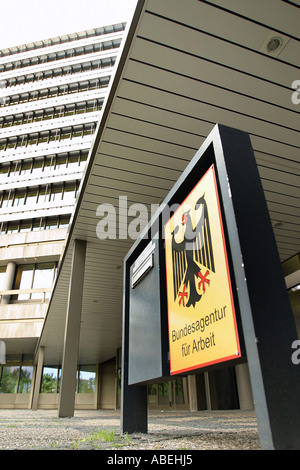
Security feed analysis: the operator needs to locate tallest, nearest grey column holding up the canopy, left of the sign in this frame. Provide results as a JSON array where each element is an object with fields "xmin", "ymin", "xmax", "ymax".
[{"xmin": 58, "ymin": 240, "xmax": 86, "ymax": 418}]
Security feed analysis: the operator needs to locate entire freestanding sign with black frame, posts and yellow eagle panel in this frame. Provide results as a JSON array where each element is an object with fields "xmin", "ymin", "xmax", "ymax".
[{"xmin": 122, "ymin": 125, "xmax": 300, "ymax": 449}]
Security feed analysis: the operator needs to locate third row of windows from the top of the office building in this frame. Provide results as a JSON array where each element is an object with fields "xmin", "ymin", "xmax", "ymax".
[{"xmin": 0, "ymin": 56, "xmax": 116, "ymax": 88}]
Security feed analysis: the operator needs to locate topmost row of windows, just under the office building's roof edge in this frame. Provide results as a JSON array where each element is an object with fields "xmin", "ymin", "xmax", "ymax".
[{"xmin": 0, "ymin": 23, "xmax": 126, "ymax": 57}]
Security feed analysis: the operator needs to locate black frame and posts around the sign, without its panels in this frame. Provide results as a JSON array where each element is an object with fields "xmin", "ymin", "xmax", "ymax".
[{"xmin": 121, "ymin": 124, "xmax": 300, "ymax": 449}]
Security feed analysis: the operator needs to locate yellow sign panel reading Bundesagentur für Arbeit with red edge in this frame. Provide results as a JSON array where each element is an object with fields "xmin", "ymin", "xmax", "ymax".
[{"xmin": 165, "ymin": 165, "xmax": 241, "ymax": 375}]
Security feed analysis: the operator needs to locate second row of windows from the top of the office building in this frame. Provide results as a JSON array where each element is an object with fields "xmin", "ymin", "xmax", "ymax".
[{"xmin": 0, "ymin": 39, "xmax": 121, "ymax": 73}]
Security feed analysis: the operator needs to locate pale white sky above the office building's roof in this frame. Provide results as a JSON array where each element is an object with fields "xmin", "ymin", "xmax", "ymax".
[{"xmin": 0, "ymin": 0, "xmax": 137, "ymax": 50}]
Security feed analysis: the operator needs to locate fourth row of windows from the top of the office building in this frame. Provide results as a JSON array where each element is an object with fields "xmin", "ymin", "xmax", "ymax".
[{"xmin": 0, "ymin": 76, "xmax": 110, "ymax": 110}]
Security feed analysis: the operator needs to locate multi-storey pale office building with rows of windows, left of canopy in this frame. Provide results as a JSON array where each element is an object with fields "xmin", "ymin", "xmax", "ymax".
[{"xmin": 0, "ymin": 23, "xmax": 126, "ymax": 407}]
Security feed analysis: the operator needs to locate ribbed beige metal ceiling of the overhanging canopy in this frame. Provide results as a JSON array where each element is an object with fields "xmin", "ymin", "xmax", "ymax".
[{"xmin": 40, "ymin": 0, "xmax": 300, "ymax": 364}]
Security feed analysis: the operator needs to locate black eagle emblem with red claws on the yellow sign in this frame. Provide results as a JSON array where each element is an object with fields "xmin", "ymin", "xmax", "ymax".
[{"xmin": 171, "ymin": 195, "xmax": 215, "ymax": 307}]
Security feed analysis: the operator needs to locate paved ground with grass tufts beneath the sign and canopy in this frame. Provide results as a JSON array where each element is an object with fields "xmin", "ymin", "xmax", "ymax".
[{"xmin": 0, "ymin": 410, "xmax": 260, "ymax": 451}]
